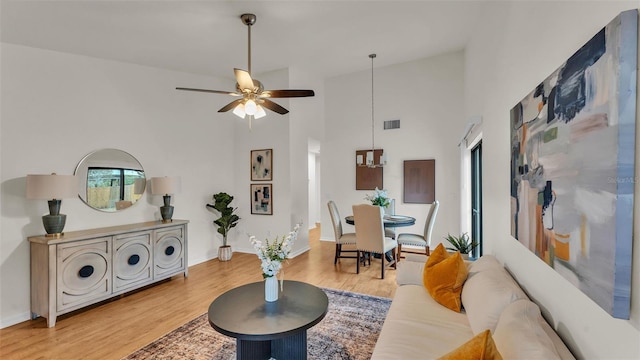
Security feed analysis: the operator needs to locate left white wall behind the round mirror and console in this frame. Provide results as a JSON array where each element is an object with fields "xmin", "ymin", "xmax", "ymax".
[{"xmin": 0, "ymin": 43, "xmax": 238, "ymax": 327}]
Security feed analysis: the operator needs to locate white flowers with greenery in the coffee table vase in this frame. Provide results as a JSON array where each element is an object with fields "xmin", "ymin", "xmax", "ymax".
[{"xmin": 249, "ymin": 223, "xmax": 302, "ymax": 279}]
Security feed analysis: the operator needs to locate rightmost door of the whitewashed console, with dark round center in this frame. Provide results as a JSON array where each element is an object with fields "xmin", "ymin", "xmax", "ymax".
[{"xmin": 153, "ymin": 226, "xmax": 185, "ymax": 280}]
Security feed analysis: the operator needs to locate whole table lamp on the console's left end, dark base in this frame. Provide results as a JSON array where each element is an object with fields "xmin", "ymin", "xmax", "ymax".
[{"xmin": 27, "ymin": 173, "xmax": 78, "ymax": 237}]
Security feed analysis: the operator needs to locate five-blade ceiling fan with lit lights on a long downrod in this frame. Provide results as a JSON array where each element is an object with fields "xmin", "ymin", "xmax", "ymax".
[{"xmin": 176, "ymin": 14, "xmax": 315, "ymax": 119}]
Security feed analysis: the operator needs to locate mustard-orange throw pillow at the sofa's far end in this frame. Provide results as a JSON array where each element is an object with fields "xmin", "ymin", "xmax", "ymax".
[{"xmin": 422, "ymin": 244, "xmax": 468, "ymax": 312}]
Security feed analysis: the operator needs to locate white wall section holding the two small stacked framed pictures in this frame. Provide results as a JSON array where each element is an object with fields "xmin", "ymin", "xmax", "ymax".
[{"xmin": 232, "ymin": 69, "xmax": 324, "ymax": 256}]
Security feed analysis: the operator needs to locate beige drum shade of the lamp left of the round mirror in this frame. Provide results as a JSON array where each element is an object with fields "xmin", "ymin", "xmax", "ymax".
[{"xmin": 27, "ymin": 174, "xmax": 78, "ymax": 200}]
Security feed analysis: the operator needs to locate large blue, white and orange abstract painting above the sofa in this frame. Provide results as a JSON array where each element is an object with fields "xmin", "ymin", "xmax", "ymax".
[{"xmin": 510, "ymin": 10, "xmax": 638, "ymax": 319}]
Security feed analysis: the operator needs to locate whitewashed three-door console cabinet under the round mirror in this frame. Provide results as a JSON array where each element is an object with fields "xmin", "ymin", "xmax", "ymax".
[{"xmin": 28, "ymin": 220, "xmax": 189, "ymax": 327}]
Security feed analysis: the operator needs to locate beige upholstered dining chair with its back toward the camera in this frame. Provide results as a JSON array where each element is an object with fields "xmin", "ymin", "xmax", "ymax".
[{"xmin": 353, "ymin": 204, "xmax": 398, "ymax": 279}]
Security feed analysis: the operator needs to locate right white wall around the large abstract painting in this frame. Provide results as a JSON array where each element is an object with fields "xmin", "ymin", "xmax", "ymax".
[{"xmin": 465, "ymin": 1, "xmax": 640, "ymax": 359}]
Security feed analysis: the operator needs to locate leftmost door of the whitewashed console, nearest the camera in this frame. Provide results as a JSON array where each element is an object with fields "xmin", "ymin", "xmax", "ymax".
[{"xmin": 57, "ymin": 237, "xmax": 111, "ymax": 311}]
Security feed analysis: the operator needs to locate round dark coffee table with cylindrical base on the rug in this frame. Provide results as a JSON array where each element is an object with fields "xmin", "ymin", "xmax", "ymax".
[{"xmin": 209, "ymin": 280, "xmax": 329, "ymax": 359}]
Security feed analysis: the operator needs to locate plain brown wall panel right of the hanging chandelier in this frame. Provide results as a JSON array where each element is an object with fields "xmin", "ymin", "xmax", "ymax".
[{"xmin": 403, "ymin": 160, "xmax": 436, "ymax": 204}]
